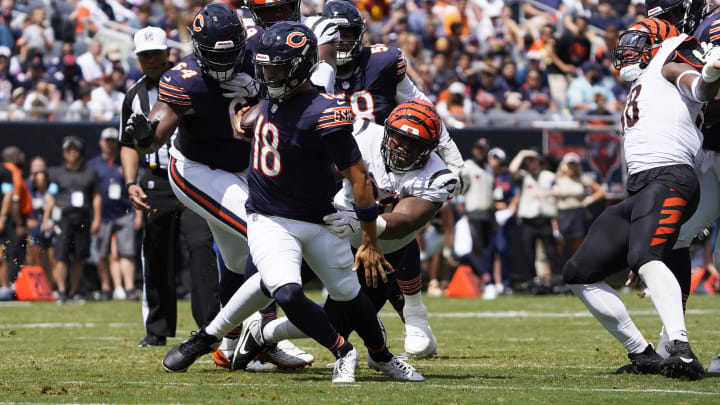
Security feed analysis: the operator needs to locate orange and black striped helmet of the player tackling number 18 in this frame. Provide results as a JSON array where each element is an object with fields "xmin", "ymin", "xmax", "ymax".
[{"xmin": 380, "ymin": 99, "xmax": 441, "ymax": 172}]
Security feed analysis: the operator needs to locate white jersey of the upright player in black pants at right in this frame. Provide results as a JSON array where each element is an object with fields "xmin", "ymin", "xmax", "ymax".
[{"xmin": 622, "ymin": 34, "xmax": 702, "ymax": 175}]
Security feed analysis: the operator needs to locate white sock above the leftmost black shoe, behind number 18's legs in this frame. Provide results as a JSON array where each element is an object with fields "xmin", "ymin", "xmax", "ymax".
[{"xmin": 205, "ymin": 273, "xmax": 272, "ymax": 336}]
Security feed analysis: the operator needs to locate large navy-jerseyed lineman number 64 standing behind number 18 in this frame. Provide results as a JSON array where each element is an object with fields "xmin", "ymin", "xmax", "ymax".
[{"xmin": 127, "ymin": 3, "xmax": 311, "ymax": 370}]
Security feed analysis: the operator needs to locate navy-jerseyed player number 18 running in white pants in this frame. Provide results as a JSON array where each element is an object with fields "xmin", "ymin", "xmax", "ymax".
[{"xmin": 245, "ymin": 22, "xmax": 423, "ymax": 382}]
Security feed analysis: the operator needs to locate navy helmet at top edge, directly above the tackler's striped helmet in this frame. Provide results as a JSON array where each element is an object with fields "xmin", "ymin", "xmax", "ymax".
[{"xmin": 323, "ymin": 0, "xmax": 366, "ymax": 66}]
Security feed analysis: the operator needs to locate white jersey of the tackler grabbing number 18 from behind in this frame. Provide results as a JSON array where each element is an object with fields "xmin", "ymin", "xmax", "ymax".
[{"xmin": 335, "ymin": 120, "xmax": 457, "ymax": 253}]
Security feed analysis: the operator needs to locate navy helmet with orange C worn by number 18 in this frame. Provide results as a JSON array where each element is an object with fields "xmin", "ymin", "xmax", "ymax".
[{"xmin": 255, "ymin": 22, "xmax": 318, "ymax": 99}]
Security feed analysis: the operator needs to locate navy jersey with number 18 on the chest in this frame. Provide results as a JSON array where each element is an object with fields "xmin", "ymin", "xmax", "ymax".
[{"xmin": 246, "ymin": 89, "xmax": 361, "ymax": 223}]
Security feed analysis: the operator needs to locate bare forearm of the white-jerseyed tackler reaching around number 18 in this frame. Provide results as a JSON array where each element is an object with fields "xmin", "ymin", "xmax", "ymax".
[{"xmin": 380, "ymin": 197, "xmax": 440, "ymax": 239}]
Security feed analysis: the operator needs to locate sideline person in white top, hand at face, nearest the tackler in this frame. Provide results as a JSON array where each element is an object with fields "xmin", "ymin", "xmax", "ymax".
[{"xmin": 509, "ymin": 149, "xmax": 560, "ymax": 285}]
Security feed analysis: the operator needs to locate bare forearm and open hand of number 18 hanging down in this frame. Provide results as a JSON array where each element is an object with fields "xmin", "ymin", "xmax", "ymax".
[{"xmin": 340, "ymin": 160, "xmax": 393, "ymax": 287}]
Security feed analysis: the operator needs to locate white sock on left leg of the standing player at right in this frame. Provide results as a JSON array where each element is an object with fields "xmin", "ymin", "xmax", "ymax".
[{"xmin": 568, "ymin": 281, "xmax": 648, "ymax": 353}]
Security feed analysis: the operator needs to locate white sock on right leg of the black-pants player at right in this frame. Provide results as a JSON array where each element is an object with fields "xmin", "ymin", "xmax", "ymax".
[{"xmin": 638, "ymin": 260, "xmax": 688, "ymax": 342}]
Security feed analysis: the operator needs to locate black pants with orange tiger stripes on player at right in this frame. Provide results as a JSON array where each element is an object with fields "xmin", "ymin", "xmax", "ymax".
[{"xmin": 563, "ymin": 165, "xmax": 700, "ymax": 284}]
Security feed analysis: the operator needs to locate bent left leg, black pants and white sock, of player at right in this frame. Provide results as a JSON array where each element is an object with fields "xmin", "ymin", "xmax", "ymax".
[{"xmin": 563, "ymin": 202, "xmax": 648, "ymax": 355}]
